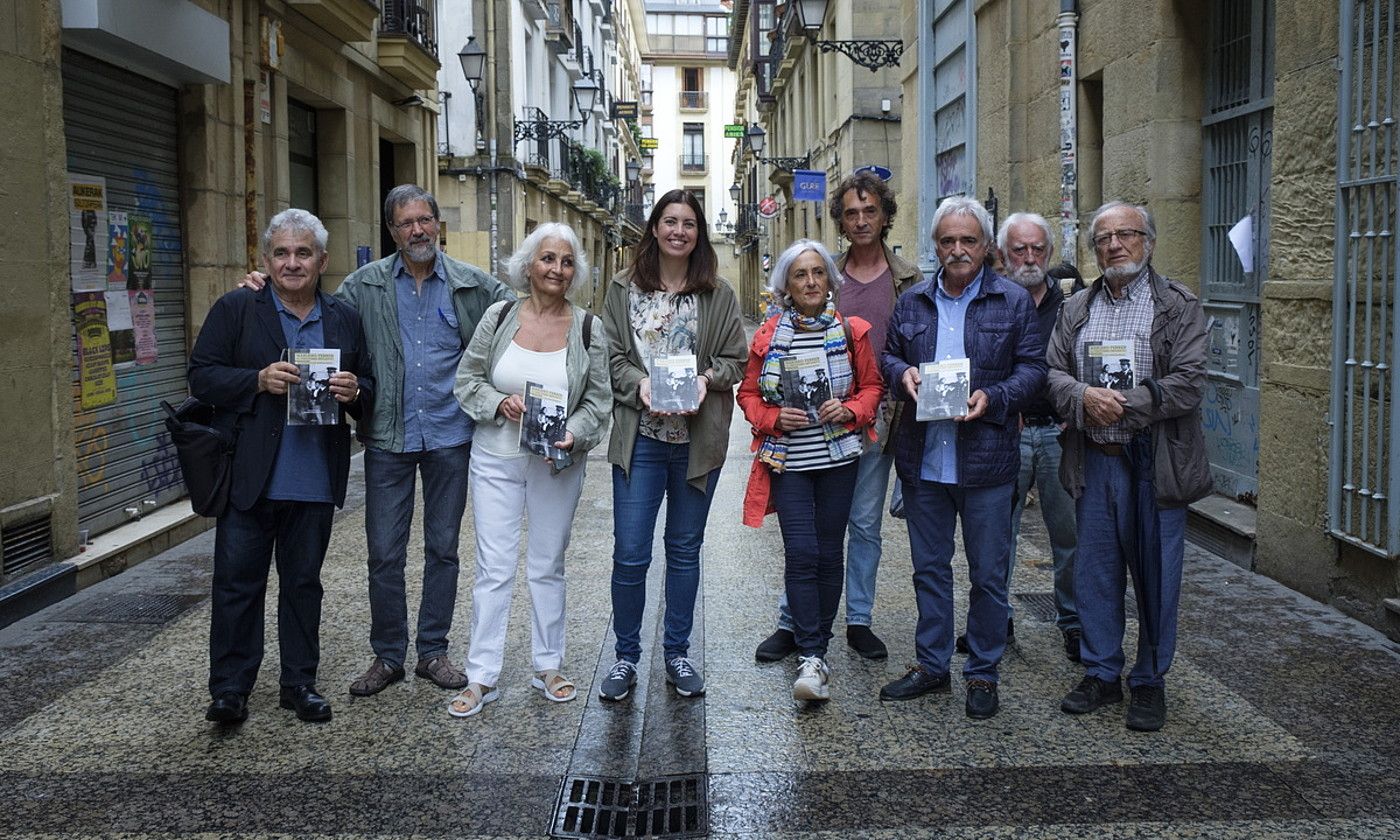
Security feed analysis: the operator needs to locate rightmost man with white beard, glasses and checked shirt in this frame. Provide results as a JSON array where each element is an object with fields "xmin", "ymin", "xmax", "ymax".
[{"xmin": 1047, "ymin": 202, "xmax": 1211, "ymax": 732}]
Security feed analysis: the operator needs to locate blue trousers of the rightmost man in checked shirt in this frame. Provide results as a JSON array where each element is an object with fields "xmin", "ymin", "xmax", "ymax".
[{"xmin": 1074, "ymin": 447, "xmax": 1186, "ymax": 687}]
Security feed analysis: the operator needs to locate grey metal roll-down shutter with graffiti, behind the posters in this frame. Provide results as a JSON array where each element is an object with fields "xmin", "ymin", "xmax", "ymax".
[{"xmin": 63, "ymin": 49, "xmax": 186, "ymax": 533}]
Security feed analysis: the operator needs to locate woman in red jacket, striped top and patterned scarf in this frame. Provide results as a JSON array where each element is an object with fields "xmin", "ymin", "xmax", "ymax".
[{"xmin": 739, "ymin": 239, "xmax": 883, "ymax": 700}]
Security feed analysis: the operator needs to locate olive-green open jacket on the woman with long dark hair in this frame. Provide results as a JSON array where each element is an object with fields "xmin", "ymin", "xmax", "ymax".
[{"xmin": 603, "ymin": 270, "xmax": 749, "ymax": 491}]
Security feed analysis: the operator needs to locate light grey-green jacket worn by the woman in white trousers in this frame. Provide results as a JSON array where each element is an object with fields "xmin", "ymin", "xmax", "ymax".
[{"xmin": 454, "ymin": 298, "xmax": 612, "ymax": 469}]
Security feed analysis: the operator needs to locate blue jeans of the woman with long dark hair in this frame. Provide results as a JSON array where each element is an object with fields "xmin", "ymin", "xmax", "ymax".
[{"xmin": 612, "ymin": 434, "xmax": 720, "ymax": 662}]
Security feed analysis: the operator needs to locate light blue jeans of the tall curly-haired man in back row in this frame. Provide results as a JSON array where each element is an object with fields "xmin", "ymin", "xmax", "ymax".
[{"xmin": 778, "ymin": 449, "xmax": 895, "ymax": 630}]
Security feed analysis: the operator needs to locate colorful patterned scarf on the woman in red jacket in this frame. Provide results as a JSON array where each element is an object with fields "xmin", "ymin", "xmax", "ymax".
[{"xmin": 759, "ymin": 301, "xmax": 861, "ymax": 472}]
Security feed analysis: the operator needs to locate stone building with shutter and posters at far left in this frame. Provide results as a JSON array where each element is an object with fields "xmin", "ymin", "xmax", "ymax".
[{"xmin": 0, "ymin": 0, "xmax": 438, "ymax": 620}]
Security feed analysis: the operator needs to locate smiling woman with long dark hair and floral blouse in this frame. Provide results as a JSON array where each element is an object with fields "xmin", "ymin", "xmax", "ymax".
[{"xmin": 598, "ymin": 189, "xmax": 745, "ymax": 700}]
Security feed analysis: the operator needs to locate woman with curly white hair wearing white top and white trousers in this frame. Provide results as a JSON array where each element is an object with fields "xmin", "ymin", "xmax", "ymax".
[{"xmin": 448, "ymin": 223, "xmax": 612, "ymax": 717}]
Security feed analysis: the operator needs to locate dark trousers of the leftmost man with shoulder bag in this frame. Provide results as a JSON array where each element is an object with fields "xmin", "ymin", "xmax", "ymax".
[{"xmin": 209, "ymin": 498, "xmax": 335, "ymax": 697}]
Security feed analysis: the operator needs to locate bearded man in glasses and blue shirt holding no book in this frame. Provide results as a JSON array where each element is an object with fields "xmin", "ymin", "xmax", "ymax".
[{"xmin": 244, "ymin": 183, "xmax": 515, "ymax": 697}]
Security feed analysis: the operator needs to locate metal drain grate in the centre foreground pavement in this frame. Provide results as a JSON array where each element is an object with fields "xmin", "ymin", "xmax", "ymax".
[{"xmin": 550, "ymin": 774, "xmax": 710, "ymax": 837}]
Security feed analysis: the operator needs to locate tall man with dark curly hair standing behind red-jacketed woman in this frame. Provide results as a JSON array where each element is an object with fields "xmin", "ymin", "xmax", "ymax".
[{"xmin": 753, "ymin": 172, "xmax": 923, "ymax": 662}]
